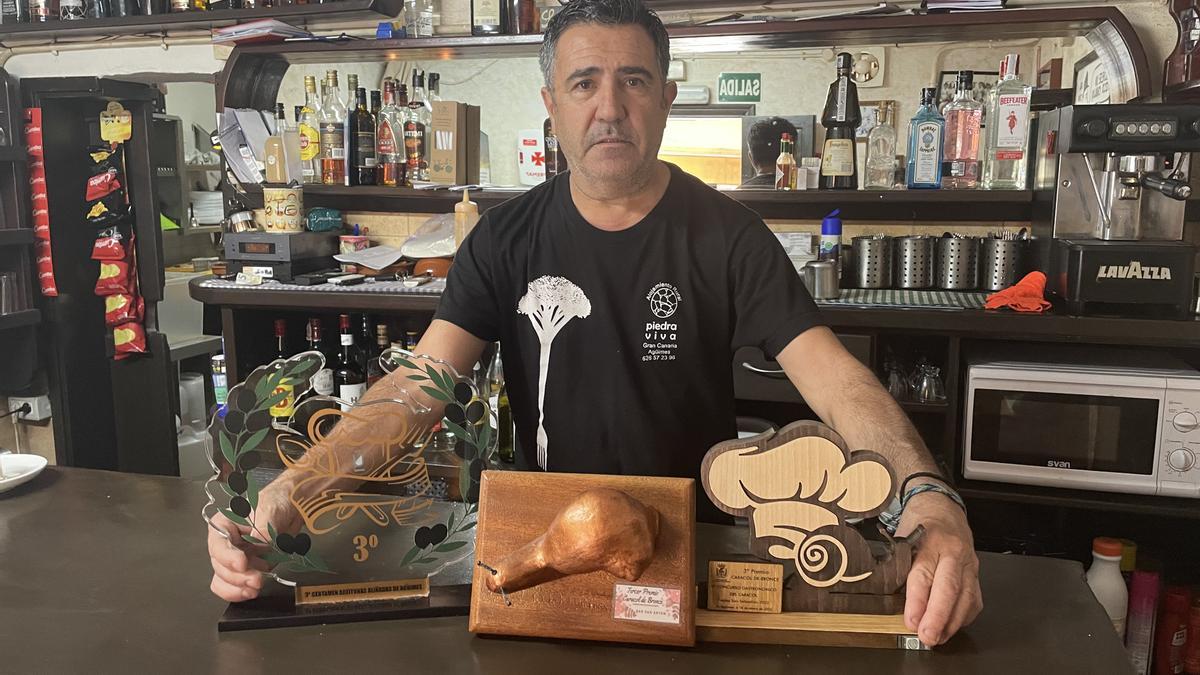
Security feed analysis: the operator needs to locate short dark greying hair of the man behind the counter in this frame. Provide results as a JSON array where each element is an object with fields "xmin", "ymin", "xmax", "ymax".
[{"xmin": 538, "ymin": 0, "xmax": 671, "ymax": 88}]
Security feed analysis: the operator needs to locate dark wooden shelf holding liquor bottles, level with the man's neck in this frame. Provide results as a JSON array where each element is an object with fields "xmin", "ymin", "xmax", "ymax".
[{"xmin": 238, "ymin": 185, "xmax": 1033, "ymax": 221}]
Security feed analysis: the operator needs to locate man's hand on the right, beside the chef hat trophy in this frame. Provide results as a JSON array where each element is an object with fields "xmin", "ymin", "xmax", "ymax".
[{"xmin": 896, "ymin": 492, "xmax": 983, "ymax": 646}]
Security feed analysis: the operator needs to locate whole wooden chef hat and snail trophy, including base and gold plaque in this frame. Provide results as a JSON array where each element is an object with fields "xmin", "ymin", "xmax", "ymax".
[{"xmin": 696, "ymin": 422, "xmax": 923, "ymax": 649}]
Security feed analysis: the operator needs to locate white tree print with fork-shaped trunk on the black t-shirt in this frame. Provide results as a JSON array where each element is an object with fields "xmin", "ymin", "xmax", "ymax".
[{"xmin": 517, "ymin": 276, "xmax": 592, "ymax": 470}]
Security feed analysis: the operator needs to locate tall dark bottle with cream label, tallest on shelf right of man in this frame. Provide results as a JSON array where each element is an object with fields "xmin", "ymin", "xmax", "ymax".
[{"xmin": 820, "ymin": 52, "xmax": 863, "ymax": 190}]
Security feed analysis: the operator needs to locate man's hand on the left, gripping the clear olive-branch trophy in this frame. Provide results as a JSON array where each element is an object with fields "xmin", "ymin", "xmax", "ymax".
[{"xmin": 209, "ymin": 484, "xmax": 299, "ymax": 602}]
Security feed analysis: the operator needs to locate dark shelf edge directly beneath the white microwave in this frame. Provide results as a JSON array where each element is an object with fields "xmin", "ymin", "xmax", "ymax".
[{"xmin": 955, "ymin": 479, "xmax": 1200, "ymax": 520}]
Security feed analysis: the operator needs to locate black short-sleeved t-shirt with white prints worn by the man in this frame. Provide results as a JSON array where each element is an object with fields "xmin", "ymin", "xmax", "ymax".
[{"xmin": 436, "ymin": 166, "xmax": 822, "ymax": 520}]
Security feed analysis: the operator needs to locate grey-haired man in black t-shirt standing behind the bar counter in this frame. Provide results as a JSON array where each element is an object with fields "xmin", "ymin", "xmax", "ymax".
[{"xmin": 209, "ymin": 0, "xmax": 982, "ymax": 645}]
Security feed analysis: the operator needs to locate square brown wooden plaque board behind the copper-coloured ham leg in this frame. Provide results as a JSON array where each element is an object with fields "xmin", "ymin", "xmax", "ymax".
[{"xmin": 469, "ymin": 471, "xmax": 696, "ymax": 646}]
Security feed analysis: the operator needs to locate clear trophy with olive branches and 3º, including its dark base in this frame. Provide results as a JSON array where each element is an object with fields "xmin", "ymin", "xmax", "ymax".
[{"xmin": 204, "ymin": 350, "xmax": 496, "ymax": 629}]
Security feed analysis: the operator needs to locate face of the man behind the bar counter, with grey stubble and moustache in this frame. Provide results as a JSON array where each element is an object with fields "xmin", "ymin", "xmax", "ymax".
[{"xmin": 541, "ymin": 24, "xmax": 676, "ymax": 184}]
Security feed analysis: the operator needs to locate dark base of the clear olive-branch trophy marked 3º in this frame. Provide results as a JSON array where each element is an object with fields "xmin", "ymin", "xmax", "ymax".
[{"xmin": 217, "ymin": 584, "xmax": 470, "ymax": 632}]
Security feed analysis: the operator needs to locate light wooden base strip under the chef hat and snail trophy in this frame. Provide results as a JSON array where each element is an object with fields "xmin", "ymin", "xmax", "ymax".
[{"xmin": 696, "ymin": 609, "xmax": 929, "ymax": 650}]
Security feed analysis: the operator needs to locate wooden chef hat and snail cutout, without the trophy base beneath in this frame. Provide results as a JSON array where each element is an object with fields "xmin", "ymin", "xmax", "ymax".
[{"xmin": 701, "ymin": 422, "xmax": 916, "ymax": 613}]
